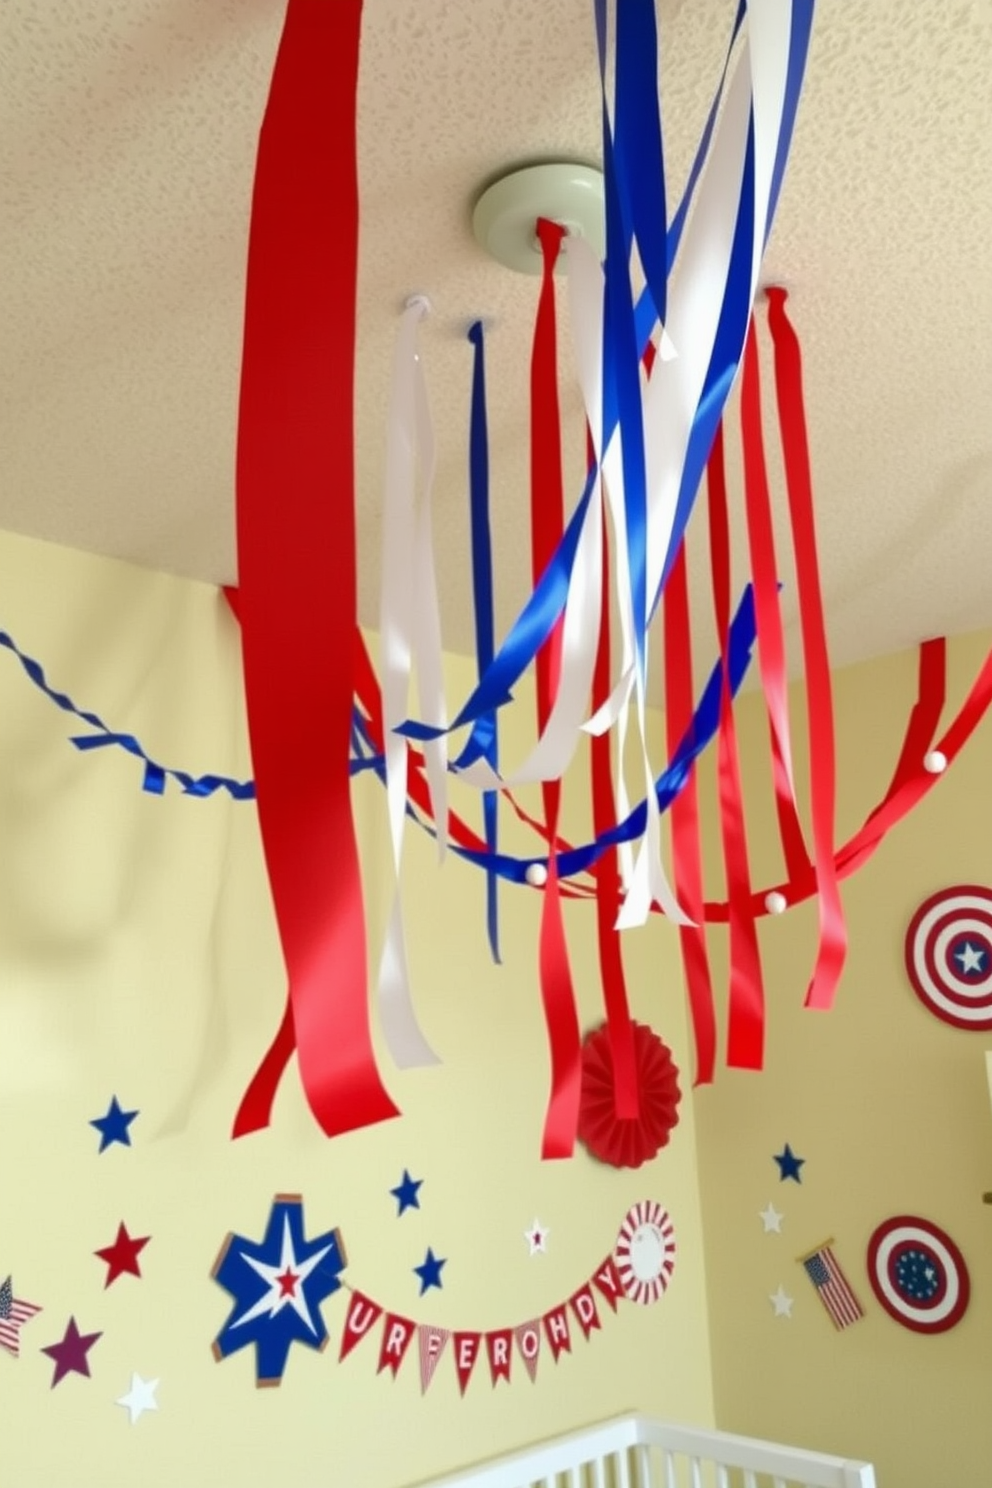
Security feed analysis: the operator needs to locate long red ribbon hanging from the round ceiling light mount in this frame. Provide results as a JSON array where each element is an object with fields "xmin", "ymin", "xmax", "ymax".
[{"xmin": 531, "ymin": 217, "xmax": 582, "ymax": 1158}]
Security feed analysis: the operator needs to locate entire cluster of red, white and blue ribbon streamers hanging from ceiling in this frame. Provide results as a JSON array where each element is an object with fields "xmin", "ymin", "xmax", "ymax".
[{"xmin": 214, "ymin": 0, "xmax": 992, "ymax": 1156}]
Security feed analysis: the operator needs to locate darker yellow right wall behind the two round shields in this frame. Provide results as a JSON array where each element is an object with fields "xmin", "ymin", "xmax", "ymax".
[{"xmin": 696, "ymin": 637, "xmax": 992, "ymax": 1488}]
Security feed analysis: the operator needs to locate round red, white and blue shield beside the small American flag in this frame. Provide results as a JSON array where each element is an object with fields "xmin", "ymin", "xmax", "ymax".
[{"xmin": 869, "ymin": 1214, "xmax": 971, "ymax": 1333}]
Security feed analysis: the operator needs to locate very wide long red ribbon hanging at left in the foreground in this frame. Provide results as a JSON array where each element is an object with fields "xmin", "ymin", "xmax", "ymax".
[{"xmin": 233, "ymin": 0, "xmax": 397, "ymax": 1135}]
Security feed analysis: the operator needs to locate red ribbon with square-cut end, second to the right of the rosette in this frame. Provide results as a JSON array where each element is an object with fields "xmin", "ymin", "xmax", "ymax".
[{"xmin": 706, "ymin": 427, "xmax": 764, "ymax": 1070}]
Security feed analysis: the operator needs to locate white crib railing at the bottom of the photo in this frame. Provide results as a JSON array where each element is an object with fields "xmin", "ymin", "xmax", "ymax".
[{"xmin": 419, "ymin": 1415, "xmax": 876, "ymax": 1488}]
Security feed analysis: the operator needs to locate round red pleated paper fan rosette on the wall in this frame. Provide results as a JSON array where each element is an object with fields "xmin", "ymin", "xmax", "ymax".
[{"xmin": 579, "ymin": 1022, "xmax": 681, "ymax": 1168}]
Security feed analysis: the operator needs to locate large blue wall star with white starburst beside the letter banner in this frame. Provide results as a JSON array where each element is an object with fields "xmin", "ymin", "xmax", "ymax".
[{"xmin": 211, "ymin": 1193, "xmax": 348, "ymax": 1385}]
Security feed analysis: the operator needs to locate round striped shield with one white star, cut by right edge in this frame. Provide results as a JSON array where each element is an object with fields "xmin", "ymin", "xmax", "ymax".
[{"xmin": 906, "ymin": 884, "xmax": 992, "ymax": 1028}]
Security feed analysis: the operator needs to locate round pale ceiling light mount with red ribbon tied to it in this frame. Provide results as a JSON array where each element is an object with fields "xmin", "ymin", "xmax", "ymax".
[{"xmin": 471, "ymin": 161, "xmax": 607, "ymax": 274}]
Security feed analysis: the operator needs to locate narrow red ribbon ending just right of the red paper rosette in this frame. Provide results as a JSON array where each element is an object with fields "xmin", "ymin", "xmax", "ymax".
[{"xmin": 662, "ymin": 542, "xmax": 717, "ymax": 1085}]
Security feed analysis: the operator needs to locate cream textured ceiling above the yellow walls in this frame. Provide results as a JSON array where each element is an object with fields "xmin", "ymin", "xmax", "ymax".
[{"xmin": 0, "ymin": 0, "xmax": 992, "ymax": 681}]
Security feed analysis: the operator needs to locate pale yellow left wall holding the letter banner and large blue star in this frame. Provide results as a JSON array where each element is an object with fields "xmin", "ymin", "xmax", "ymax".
[{"xmin": 0, "ymin": 536, "xmax": 711, "ymax": 1488}]
